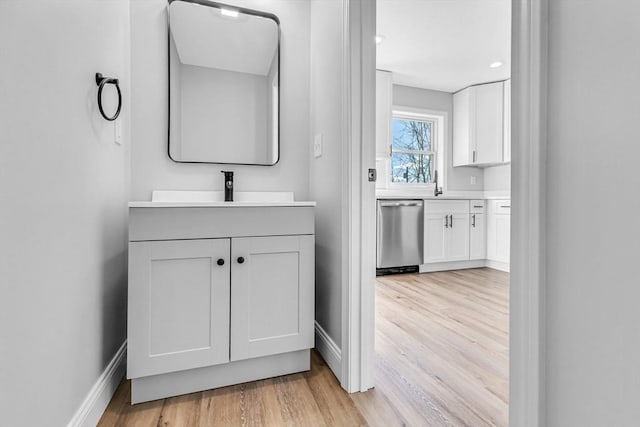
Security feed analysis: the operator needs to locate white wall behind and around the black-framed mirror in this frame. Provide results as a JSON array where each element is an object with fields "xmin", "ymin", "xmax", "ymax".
[{"xmin": 131, "ymin": 0, "xmax": 310, "ymax": 200}]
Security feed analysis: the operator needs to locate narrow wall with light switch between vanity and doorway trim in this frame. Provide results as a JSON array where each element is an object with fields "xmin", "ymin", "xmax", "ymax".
[{"xmin": 309, "ymin": 0, "xmax": 346, "ymax": 346}]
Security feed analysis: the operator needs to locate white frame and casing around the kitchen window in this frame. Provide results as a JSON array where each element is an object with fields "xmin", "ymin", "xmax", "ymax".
[{"xmin": 385, "ymin": 105, "xmax": 448, "ymax": 190}]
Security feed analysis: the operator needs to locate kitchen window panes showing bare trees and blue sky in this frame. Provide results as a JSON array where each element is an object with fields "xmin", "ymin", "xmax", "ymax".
[{"xmin": 391, "ymin": 116, "xmax": 438, "ymax": 185}]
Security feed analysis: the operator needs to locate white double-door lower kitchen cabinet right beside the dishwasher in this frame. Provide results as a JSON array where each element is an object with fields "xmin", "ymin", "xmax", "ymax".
[{"xmin": 424, "ymin": 200, "xmax": 469, "ymax": 264}]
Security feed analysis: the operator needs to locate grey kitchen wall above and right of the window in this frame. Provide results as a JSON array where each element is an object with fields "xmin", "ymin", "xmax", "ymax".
[{"xmin": 393, "ymin": 85, "xmax": 484, "ymax": 191}]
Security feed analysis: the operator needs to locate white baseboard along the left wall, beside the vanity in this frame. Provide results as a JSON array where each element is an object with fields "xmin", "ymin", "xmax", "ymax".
[{"xmin": 67, "ymin": 340, "xmax": 127, "ymax": 427}]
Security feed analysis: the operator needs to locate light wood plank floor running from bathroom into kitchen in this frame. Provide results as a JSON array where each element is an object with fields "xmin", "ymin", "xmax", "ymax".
[{"xmin": 99, "ymin": 268, "xmax": 509, "ymax": 427}]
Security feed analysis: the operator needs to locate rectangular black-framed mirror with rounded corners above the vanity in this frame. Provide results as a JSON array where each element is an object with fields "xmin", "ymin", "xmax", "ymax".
[{"xmin": 168, "ymin": 0, "xmax": 280, "ymax": 165}]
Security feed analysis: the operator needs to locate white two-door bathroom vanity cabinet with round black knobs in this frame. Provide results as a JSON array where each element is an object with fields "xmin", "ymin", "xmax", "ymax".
[{"xmin": 127, "ymin": 202, "xmax": 314, "ymax": 403}]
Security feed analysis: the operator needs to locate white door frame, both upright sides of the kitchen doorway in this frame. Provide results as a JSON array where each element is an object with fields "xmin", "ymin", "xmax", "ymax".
[{"xmin": 341, "ymin": 0, "xmax": 548, "ymax": 427}]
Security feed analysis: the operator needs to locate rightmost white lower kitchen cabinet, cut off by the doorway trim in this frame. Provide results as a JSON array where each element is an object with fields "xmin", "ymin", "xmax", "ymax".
[{"xmin": 487, "ymin": 200, "xmax": 511, "ymax": 270}]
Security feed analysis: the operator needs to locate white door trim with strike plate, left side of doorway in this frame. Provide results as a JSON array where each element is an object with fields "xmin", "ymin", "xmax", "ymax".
[{"xmin": 341, "ymin": 0, "xmax": 376, "ymax": 392}]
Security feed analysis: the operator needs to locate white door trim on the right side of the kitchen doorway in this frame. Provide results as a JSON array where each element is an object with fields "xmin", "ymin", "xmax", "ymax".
[{"xmin": 509, "ymin": 0, "xmax": 548, "ymax": 427}]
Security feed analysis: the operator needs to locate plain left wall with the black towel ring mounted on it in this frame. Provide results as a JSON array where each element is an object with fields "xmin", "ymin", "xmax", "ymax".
[{"xmin": 0, "ymin": 0, "xmax": 130, "ymax": 426}]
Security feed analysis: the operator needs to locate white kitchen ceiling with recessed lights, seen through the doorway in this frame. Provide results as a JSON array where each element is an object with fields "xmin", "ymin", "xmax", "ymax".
[{"xmin": 376, "ymin": 0, "xmax": 511, "ymax": 92}]
